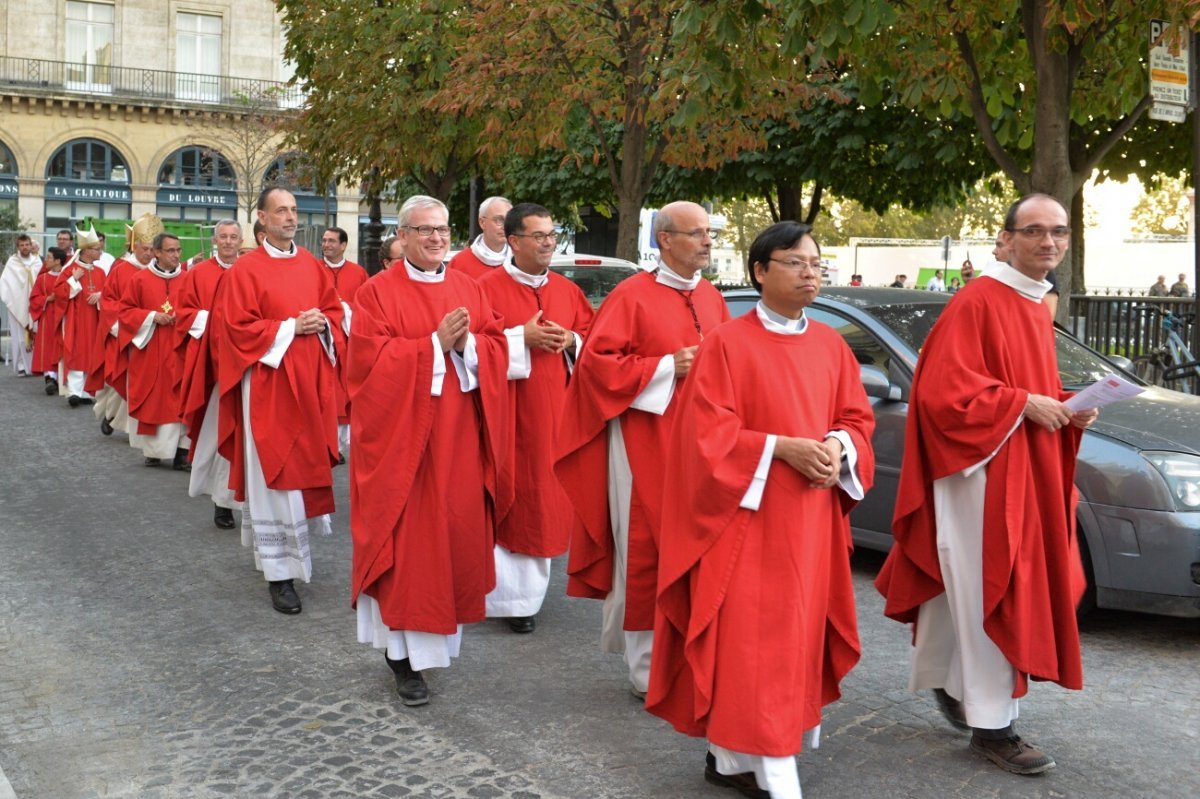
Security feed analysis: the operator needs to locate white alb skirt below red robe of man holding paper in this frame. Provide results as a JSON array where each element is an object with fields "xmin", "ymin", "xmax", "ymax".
[{"xmin": 908, "ymin": 469, "xmax": 1018, "ymax": 729}]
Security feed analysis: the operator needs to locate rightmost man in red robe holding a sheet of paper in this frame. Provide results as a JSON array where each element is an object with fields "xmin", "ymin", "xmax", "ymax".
[{"xmin": 876, "ymin": 194, "xmax": 1097, "ymax": 774}]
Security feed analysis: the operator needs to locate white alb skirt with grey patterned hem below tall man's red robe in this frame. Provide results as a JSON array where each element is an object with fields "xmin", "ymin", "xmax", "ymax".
[{"xmin": 241, "ymin": 370, "xmax": 331, "ymax": 583}]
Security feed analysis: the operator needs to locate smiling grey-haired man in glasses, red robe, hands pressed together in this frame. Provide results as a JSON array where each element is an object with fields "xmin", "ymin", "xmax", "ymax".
[{"xmin": 350, "ymin": 196, "xmax": 513, "ymax": 705}]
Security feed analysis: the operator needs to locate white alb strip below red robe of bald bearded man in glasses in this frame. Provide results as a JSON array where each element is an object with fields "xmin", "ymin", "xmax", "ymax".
[{"xmin": 600, "ymin": 419, "xmax": 654, "ymax": 692}]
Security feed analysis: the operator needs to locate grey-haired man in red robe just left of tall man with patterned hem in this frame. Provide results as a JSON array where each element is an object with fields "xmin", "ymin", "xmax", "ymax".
[{"xmin": 175, "ymin": 220, "xmax": 241, "ymax": 530}]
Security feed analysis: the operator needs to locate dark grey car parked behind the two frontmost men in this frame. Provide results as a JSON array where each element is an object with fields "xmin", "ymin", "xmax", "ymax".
[{"xmin": 725, "ymin": 287, "xmax": 1200, "ymax": 617}]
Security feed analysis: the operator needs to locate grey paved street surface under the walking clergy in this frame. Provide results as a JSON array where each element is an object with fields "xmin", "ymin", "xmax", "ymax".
[{"xmin": 0, "ymin": 372, "xmax": 1200, "ymax": 799}]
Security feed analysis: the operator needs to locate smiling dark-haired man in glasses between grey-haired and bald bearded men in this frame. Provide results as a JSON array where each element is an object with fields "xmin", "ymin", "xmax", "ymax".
[{"xmin": 479, "ymin": 203, "xmax": 593, "ymax": 632}]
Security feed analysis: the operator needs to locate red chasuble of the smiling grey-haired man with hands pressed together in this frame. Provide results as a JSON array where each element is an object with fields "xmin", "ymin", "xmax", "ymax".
[{"xmin": 350, "ymin": 265, "xmax": 512, "ymax": 635}]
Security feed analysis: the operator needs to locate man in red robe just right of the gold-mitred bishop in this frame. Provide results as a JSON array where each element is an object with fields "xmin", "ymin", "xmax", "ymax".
[{"xmin": 116, "ymin": 232, "xmax": 190, "ymax": 471}]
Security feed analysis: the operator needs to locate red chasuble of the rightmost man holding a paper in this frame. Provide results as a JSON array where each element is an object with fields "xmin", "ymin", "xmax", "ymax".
[{"xmin": 875, "ymin": 276, "xmax": 1085, "ymax": 697}]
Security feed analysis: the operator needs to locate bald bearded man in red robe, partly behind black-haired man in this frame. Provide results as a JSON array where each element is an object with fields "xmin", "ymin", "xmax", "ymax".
[{"xmin": 554, "ymin": 202, "xmax": 730, "ymax": 697}]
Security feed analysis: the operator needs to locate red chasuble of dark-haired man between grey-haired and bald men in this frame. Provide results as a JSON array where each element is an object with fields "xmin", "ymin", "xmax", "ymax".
[{"xmin": 479, "ymin": 266, "xmax": 594, "ymax": 558}]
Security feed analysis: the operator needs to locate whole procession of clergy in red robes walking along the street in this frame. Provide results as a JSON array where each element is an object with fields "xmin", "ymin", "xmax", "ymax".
[{"xmin": 0, "ymin": 187, "xmax": 1094, "ymax": 798}]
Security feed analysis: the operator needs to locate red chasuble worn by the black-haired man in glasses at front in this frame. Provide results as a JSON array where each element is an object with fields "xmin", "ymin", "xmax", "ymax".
[{"xmin": 646, "ymin": 312, "xmax": 875, "ymax": 757}]
